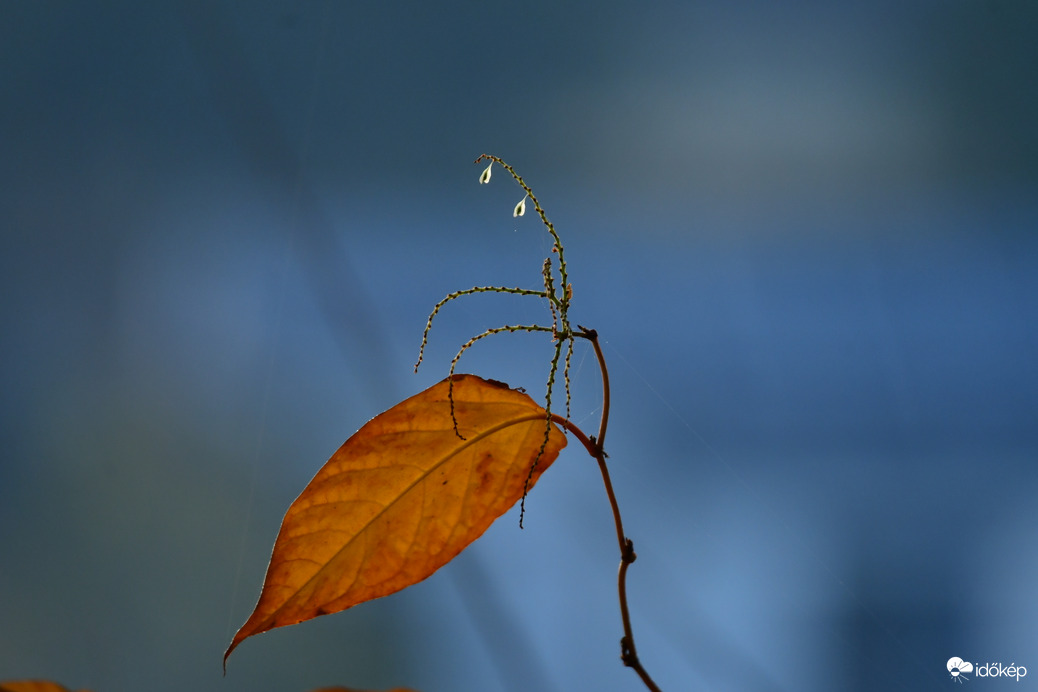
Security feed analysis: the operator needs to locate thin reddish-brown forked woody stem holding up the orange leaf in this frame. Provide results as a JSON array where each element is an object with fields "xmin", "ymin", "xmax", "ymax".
[{"xmin": 551, "ymin": 327, "xmax": 660, "ymax": 692}]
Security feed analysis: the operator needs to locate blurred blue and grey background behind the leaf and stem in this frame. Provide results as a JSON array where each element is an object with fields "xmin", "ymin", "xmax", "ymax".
[{"xmin": 0, "ymin": 0, "xmax": 1038, "ymax": 692}]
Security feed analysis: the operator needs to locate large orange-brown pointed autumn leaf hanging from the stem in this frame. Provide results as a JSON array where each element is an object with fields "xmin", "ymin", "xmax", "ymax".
[{"xmin": 223, "ymin": 375, "xmax": 566, "ymax": 661}]
